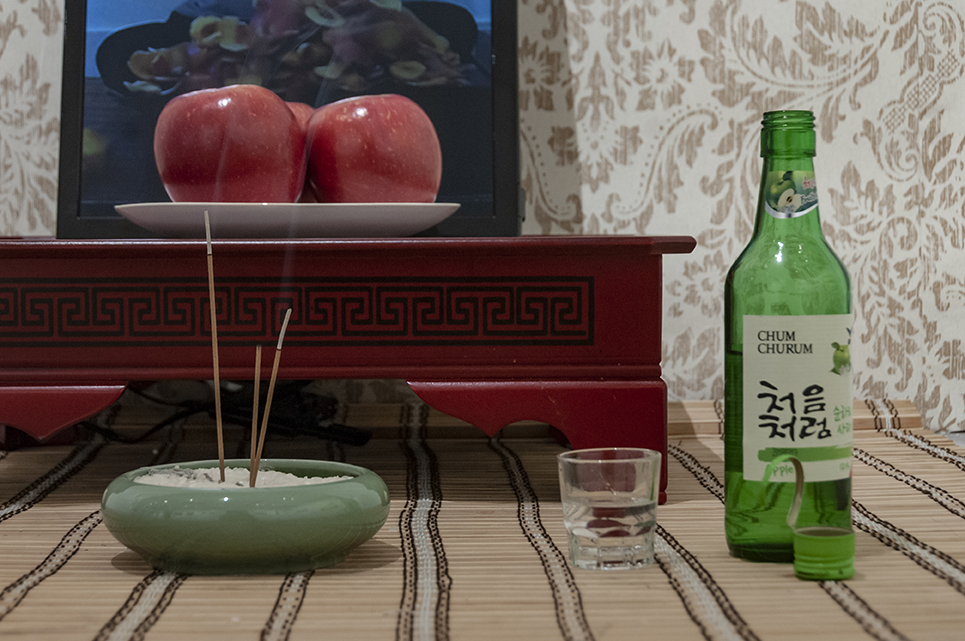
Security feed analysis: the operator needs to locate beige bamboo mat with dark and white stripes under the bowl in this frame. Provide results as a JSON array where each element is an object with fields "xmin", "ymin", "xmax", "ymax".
[{"xmin": 0, "ymin": 401, "xmax": 965, "ymax": 641}]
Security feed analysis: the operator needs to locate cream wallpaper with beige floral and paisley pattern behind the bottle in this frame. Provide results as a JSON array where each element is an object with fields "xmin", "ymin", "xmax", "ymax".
[{"xmin": 0, "ymin": 0, "xmax": 965, "ymax": 430}]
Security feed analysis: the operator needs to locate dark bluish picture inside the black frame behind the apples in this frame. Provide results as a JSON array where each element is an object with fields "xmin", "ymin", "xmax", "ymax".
[{"xmin": 78, "ymin": 0, "xmax": 494, "ymax": 229}]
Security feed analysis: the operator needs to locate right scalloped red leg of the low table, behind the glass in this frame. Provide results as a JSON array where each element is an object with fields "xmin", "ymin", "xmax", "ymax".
[{"xmin": 409, "ymin": 379, "xmax": 667, "ymax": 503}]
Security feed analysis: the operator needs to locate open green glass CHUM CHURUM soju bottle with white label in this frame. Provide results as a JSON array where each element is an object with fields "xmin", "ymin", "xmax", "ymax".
[{"xmin": 724, "ymin": 111, "xmax": 852, "ymax": 562}]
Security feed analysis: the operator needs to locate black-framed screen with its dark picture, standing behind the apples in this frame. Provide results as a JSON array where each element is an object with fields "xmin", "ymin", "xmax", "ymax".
[{"xmin": 57, "ymin": 0, "xmax": 522, "ymax": 238}]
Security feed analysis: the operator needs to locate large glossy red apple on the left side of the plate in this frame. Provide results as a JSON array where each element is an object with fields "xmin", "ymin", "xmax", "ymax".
[{"xmin": 154, "ymin": 85, "xmax": 307, "ymax": 203}]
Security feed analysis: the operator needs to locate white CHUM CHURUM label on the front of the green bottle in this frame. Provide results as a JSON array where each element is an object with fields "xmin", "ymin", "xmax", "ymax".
[{"xmin": 743, "ymin": 314, "xmax": 852, "ymax": 482}]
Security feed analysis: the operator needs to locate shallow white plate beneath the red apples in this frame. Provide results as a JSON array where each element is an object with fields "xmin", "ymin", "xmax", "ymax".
[{"xmin": 114, "ymin": 203, "xmax": 459, "ymax": 238}]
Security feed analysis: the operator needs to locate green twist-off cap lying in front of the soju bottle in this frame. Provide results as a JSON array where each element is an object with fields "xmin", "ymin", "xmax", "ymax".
[{"xmin": 794, "ymin": 525, "xmax": 854, "ymax": 581}]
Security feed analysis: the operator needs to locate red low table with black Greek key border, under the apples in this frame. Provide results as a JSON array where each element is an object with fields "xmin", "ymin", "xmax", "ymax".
[{"xmin": 0, "ymin": 236, "xmax": 696, "ymax": 500}]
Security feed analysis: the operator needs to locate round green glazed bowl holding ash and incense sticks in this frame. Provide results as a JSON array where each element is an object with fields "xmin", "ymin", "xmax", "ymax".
[{"xmin": 101, "ymin": 459, "xmax": 389, "ymax": 575}]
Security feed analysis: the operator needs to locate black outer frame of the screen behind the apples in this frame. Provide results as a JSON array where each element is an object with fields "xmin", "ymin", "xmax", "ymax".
[{"xmin": 56, "ymin": 0, "xmax": 524, "ymax": 239}]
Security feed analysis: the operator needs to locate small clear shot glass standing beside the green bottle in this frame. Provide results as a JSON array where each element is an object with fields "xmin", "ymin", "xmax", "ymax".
[{"xmin": 557, "ymin": 447, "xmax": 660, "ymax": 570}]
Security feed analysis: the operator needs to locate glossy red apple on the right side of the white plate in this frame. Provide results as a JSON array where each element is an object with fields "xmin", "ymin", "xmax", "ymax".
[{"xmin": 308, "ymin": 94, "xmax": 442, "ymax": 203}]
